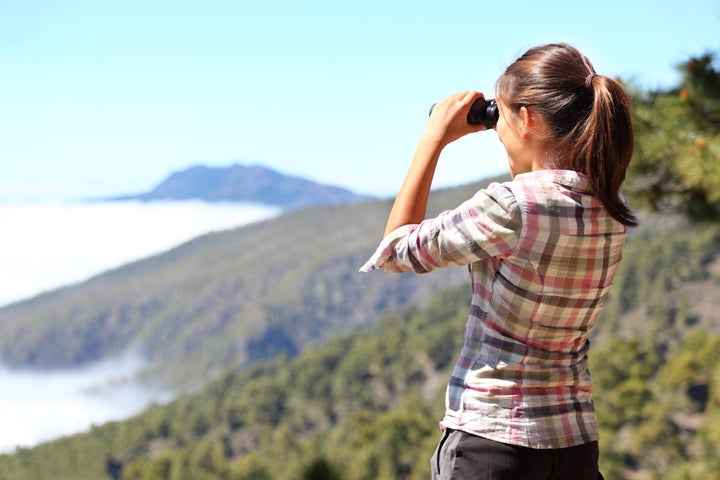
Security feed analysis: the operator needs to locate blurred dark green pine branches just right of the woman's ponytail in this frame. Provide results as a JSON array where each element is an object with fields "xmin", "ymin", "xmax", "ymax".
[{"xmin": 626, "ymin": 53, "xmax": 720, "ymax": 219}]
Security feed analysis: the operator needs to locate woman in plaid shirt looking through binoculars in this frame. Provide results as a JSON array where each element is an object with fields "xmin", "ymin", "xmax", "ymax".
[{"xmin": 361, "ymin": 44, "xmax": 637, "ymax": 480}]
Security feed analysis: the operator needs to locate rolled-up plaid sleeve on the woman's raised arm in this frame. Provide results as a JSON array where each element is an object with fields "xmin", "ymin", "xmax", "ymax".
[{"xmin": 360, "ymin": 183, "xmax": 522, "ymax": 273}]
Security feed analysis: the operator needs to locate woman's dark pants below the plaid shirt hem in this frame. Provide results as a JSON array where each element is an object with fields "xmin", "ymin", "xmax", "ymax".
[{"xmin": 431, "ymin": 429, "xmax": 602, "ymax": 480}]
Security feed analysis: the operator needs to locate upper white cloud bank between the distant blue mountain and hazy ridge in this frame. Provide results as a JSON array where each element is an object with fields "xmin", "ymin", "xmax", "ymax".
[{"xmin": 0, "ymin": 201, "xmax": 279, "ymax": 305}]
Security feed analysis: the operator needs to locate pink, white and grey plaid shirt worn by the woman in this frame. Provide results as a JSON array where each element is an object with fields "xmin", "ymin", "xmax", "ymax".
[{"xmin": 361, "ymin": 170, "xmax": 625, "ymax": 448}]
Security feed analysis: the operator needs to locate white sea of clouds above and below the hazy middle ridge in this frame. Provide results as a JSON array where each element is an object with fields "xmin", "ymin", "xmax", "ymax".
[{"xmin": 0, "ymin": 201, "xmax": 279, "ymax": 452}]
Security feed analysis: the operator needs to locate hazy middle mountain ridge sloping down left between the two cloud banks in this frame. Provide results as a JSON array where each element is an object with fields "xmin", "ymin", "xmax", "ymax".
[{"xmin": 0, "ymin": 173, "xmax": 504, "ymax": 389}]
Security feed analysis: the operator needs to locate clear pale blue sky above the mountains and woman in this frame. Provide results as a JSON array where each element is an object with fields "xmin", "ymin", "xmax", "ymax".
[{"xmin": 0, "ymin": 0, "xmax": 720, "ymax": 200}]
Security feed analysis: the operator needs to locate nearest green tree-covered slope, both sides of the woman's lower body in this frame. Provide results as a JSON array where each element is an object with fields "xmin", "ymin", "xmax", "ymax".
[{"xmin": 0, "ymin": 219, "xmax": 720, "ymax": 480}]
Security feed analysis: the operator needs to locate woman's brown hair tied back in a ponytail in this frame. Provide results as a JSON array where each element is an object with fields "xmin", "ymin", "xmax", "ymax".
[{"xmin": 496, "ymin": 43, "xmax": 638, "ymax": 226}]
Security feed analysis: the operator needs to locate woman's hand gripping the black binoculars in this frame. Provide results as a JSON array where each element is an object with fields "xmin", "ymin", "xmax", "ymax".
[{"xmin": 421, "ymin": 91, "xmax": 487, "ymax": 147}]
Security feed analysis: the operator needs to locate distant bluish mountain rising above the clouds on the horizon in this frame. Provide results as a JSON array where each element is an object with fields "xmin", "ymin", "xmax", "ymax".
[{"xmin": 111, "ymin": 164, "xmax": 370, "ymax": 209}]
